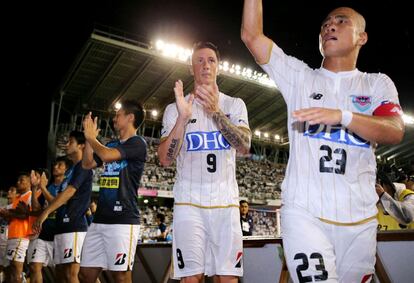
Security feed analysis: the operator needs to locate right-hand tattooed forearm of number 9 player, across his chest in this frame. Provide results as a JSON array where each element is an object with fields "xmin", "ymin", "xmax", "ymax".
[{"xmin": 213, "ymin": 112, "xmax": 249, "ymax": 152}]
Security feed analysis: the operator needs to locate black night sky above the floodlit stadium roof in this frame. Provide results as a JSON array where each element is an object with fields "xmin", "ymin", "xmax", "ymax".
[{"xmin": 0, "ymin": 0, "xmax": 414, "ymax": 190}]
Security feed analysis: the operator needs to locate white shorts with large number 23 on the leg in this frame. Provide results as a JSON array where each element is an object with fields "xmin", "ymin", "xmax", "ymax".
[{"xmin": 281, "ymin": 207, "xmax": 378, "ymax": 283}]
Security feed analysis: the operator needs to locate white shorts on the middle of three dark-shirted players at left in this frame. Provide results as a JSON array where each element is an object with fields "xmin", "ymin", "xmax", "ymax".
[{"xmin": 53, "ymin": 232, "xmax": 86, "ymax": 264}]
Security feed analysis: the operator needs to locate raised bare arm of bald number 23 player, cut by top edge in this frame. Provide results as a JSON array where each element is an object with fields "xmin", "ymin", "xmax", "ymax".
[{"xmin": 241, "ymin": 0, "xmax": 273, "ymax": 65}]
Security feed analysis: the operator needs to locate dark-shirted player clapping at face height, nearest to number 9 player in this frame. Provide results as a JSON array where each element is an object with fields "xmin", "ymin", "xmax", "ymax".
[{"xmin": 80, "ymin": 100, "xmax": 147, "ymax": 283}]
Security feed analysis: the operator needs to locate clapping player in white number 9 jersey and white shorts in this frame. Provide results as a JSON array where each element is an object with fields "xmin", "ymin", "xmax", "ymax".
[{"xmin": 158, "ymin": 42, "xmax": 251, "ymax": 282}]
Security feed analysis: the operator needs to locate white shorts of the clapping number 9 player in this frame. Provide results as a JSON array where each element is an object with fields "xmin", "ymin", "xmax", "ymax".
[{"xmin": 173, "ymin": 205, "xmax": 243, "ymax": 278}]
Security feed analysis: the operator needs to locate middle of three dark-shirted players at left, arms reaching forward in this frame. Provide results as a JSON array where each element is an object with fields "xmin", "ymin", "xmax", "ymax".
[{"xmin": 33, "ymin": 131, "xmax": 92, "ymax": 282}]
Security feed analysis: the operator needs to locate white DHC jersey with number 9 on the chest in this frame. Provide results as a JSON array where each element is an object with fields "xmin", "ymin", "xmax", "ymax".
[{"xmin": 161, "ymin": 93, "xmax": 249, "ymax": 208}]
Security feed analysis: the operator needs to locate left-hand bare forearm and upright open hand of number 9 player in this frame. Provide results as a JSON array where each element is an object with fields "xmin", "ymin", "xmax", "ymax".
[{"xmin": 158, "ymin": 80, "xmax": 194, "ymax": 166}]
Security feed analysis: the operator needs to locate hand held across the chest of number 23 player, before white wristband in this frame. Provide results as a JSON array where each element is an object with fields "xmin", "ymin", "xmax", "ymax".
[{"xmin": 293, "ymin": 107, "xmax": 342, "ymax": 125}]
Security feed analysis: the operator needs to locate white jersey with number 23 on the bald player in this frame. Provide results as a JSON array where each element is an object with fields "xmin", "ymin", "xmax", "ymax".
[{"xmin": 262, "ymin": 44, "xmax": 400, "ymax": 223}]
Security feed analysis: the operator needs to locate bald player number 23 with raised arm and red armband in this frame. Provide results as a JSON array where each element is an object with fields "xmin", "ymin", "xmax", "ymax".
[{"xmin": 242, "ymin": 0, "xmax": 404, "ymax": 282}]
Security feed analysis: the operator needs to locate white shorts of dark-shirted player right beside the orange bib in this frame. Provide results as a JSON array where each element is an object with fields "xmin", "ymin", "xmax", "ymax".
[{"xmin": 27, "ymin": 238, "xmax": 54, "ymax": 266}]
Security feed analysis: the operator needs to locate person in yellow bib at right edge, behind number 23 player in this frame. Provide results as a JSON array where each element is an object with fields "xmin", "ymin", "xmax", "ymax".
[{"xmin": 375, "ymin": 172, "xmax": 414, "ymax": 230}]
